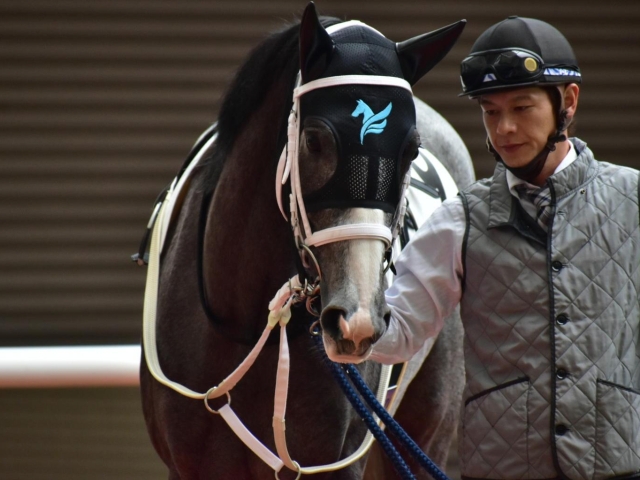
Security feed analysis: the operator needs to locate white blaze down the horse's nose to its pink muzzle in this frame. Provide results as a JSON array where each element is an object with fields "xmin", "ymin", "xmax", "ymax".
[{"xmin": 340, "ymin": 208, "xmax": 386, "ymax": 345}]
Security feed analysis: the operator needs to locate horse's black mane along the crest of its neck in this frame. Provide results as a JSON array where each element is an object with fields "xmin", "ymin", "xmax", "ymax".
[{"xmin": 206, "ymin": 17, "xmax": 342, "ymax": 193}]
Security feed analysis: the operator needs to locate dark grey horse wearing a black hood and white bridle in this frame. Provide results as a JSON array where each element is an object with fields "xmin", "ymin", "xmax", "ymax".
[{"xmin": 140, "ymin": 3, "xmax": 473, "ymax": 480}]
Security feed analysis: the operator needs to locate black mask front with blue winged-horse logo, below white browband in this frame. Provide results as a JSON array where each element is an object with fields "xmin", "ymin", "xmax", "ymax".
[{"xmin": 300, "ymin": 85, "xmax": 415, "ymax": 213}]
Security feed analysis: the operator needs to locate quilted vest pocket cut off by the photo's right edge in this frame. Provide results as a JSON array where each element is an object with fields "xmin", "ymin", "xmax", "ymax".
[{"xmin": 594, "ymin": 380, "xmax": 640, "ymax": 479}]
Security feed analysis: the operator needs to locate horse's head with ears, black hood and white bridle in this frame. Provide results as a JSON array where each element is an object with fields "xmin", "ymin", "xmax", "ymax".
[{"xmin": 283, "ymin": 3, "xmax": 464, "ymax": 362}]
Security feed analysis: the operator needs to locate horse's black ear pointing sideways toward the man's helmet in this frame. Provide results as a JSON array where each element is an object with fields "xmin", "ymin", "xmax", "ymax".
[{"xmin": 396, "ymin": 20, "xmax": 467, "ymax": 85}]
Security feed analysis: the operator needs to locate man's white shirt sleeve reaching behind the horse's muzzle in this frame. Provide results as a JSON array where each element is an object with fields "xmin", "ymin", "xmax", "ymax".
[{"xmin": 369, "ymin": 197, "xmax": 466, "ymax": 364}]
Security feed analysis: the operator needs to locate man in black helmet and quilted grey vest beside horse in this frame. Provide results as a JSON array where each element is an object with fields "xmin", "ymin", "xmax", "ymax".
[{"xmin": 370, "ymin": 17, "xmax": 640, "ymax": 480}]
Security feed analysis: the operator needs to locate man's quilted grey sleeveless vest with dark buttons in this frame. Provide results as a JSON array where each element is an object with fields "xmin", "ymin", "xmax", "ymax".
[{"xmin": 460, "ymin": 139, "xmax": 640, "ymax": 480}]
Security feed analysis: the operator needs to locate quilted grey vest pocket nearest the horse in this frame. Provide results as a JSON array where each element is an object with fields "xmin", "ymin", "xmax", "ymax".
[{"xmin": 460, "ymin": 378, "xmax": 529, "ymax": 478}]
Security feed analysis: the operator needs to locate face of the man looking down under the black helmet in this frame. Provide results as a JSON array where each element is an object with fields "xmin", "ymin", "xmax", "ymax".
[{"xmin": 478, "ymin": 87, "xmax": 556, "ymax": 168}]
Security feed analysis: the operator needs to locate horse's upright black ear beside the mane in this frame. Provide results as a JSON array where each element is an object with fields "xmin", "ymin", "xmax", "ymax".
[{"xmin": 300, "ymin": 2, "xmax": 334, "ymax": 83}]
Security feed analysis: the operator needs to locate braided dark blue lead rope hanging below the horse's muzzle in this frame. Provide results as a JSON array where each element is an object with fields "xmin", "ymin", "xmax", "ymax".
[{"xmin": 314, "ymin": 335, "xmax": 449, "ymax": 480}]
